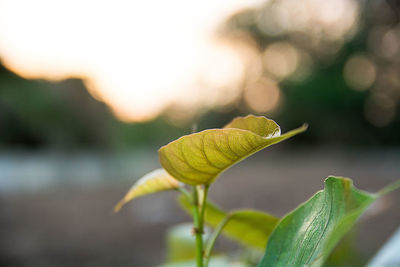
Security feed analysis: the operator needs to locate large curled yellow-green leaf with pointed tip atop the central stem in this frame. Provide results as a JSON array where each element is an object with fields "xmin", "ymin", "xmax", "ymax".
[{"xmin": 159, "ymin": 115, "xmax": 307, "ymax": 185}]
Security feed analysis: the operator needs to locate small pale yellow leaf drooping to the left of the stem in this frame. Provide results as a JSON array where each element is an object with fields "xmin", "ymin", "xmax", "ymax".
[{"xmin": 114, "ymin": 169, "xmax": 180, "ymax": 212}]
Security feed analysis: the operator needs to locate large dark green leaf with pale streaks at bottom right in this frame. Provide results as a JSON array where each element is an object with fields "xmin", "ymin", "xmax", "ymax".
[{"xmin": 258, "ymin": 177, "xmax": 378, "ymax": 267}]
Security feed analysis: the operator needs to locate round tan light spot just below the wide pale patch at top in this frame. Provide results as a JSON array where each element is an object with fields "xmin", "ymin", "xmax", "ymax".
[{"xmin": 263, "ymin": 42, "xmax": 299, "ymax": 80}]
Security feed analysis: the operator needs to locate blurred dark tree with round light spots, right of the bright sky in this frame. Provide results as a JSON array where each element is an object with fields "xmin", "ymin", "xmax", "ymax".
[{"xmin": 221, "ymin": 0, "xmax": 400, "ymax": 145}]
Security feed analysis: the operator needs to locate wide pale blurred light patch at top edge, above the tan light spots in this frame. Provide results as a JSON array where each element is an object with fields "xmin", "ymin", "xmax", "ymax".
[{"xmin": 257, "ymin": 0, "xmax": 359, "ymax": 40}]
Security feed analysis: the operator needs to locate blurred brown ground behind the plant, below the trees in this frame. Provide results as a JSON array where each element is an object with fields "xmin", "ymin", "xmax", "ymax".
[{"xmin": 0, "ymin": 147, "xmax": 400, "ymax": 267}]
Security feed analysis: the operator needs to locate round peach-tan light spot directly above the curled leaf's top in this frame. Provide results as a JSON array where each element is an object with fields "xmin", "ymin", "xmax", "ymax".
[{"xmin": 244, "ymin": 78, "xmax": 280, "ymax": 113}]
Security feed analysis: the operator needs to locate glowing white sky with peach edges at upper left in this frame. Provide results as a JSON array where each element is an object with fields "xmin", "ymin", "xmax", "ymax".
[{"xmin": 0, "ymin": 0, "xmax": 261, "ymax": 121}]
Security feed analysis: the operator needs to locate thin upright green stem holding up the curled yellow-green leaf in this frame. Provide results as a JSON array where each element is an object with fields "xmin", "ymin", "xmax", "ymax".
[{"xmin": 192, "ymin": 186, "xmax": 204, "ymax": 267}]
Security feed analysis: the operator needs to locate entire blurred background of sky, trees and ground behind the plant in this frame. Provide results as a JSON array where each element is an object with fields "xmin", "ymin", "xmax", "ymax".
[{"xmin": 0, "ymin": 0, "xmax": 400, "ymax": 266}]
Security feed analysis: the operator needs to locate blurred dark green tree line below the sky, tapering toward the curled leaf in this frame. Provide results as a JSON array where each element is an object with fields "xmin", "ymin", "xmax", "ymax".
[{"xmin": 0, "ymin": 61, "xmax": 190, "ymax": 150}]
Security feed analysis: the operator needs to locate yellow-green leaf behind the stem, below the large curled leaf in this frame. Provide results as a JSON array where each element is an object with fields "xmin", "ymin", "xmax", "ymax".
[{"xmin": 178, "ymin": 195, "xmax": 279, "ymax": 250}]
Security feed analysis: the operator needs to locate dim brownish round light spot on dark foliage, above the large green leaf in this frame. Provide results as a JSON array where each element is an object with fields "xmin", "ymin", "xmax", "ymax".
[{"xmin": 343, "ymin": 55, "xmax": 376, "ymax": 90}]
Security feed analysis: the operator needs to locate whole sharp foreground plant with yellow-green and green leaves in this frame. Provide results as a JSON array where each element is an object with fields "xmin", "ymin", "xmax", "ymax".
[{"xmin": 115, "ymin": 115, "xmax": 400, "ymax": 267}]
